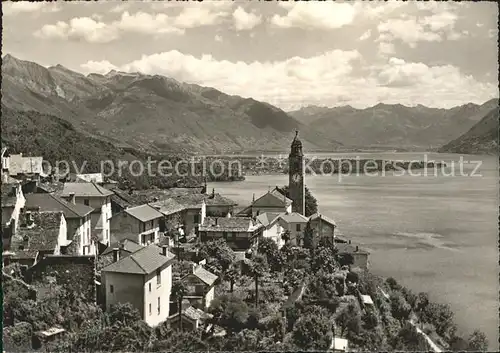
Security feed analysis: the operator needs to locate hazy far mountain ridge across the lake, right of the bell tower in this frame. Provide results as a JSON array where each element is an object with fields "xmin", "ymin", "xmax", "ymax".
[{"xmin": 289, "ymin": 99, "xmax": 498, "ymax": 149}]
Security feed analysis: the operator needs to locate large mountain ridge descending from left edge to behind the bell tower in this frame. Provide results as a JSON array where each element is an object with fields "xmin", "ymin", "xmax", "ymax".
[{"xmin": 2, "ymin": 55, "xmax": 341, "ymax": 153}]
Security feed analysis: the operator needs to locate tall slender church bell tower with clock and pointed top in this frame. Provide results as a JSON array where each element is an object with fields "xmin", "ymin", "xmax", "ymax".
[{"xmin": 288, "ymin": 130, "xmax": 306, "ymax": 215}]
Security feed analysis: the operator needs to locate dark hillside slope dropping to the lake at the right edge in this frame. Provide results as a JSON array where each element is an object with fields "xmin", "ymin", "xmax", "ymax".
[{"xmin": 439, "ymin": 108, "xmax": 499, "ymax": 154}]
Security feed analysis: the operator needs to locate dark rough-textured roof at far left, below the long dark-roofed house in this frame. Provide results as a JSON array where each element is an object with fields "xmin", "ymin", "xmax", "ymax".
[{"xmin": 11, "ymin": 211, "xmax": 63, "ymax": 251}]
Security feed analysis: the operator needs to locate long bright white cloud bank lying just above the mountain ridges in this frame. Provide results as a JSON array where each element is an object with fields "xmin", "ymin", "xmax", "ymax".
[{"xmin": 81, "ymin": 50, "xmax": 497, "ymax": 109}]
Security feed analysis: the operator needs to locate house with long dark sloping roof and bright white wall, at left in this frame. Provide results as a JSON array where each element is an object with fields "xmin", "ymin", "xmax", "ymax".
[{"xmin": 25, "ymin": 193, "xmax": 96, "ymax": 255}]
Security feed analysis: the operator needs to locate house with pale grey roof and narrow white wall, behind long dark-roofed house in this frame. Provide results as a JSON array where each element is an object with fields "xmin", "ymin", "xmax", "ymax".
[{"xmin": 60, "ymin": 182, "xmax": 113, "ymax": 245}]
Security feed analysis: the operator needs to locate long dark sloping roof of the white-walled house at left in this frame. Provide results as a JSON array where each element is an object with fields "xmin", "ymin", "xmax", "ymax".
[{"xmin": 24, "ymin": 193, "xmax": 94, "ymax": 219}]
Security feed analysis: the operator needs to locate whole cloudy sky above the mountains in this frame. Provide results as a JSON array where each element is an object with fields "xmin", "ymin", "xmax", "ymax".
[{"xmin": 2, "ymin": 0, "xmax": 498, "ymax": 110}]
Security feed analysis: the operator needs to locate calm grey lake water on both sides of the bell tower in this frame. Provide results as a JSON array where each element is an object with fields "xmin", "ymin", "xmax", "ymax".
[{"xmin": 209, "ymin": 153, "xmax": 499, "ymax": 350}]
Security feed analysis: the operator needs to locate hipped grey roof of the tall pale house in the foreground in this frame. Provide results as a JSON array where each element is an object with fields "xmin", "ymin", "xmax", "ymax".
[{"xmin": 102, "ymin": 244, "xmax": 175, "ymax": 275}]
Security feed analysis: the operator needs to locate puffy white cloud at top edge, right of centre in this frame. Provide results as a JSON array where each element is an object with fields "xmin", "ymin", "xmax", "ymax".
[{"xmin": 271, "ymin": 1, "xmax": 356, "ymax": 29}]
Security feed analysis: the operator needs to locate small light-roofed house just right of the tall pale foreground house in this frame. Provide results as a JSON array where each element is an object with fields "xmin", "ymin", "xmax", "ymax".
[{"xmin": 181, "ymin": 264, "xmax": 218, "ymax": 310}]
